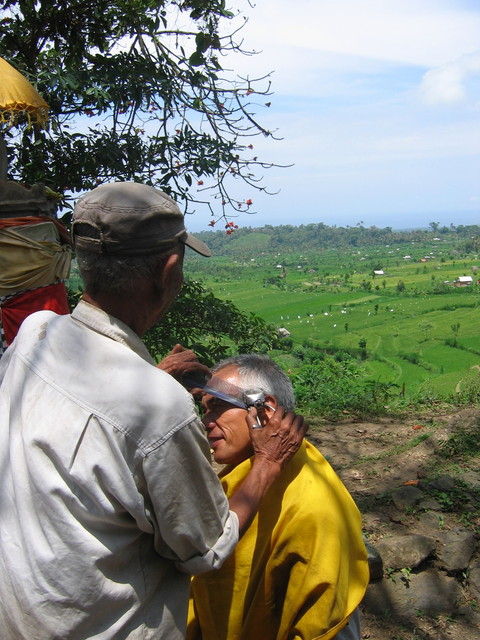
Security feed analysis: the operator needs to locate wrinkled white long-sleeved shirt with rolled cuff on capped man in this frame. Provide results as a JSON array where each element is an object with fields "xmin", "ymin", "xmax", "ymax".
[{"xmin": 0, "ymin": 302, "xmax": 238, "ymax": 640}]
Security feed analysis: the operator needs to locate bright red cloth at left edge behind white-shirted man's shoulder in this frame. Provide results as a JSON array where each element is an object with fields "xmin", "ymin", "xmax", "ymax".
[{"xmin": 1, "ymin": 282, "xmax": 70, "ymax": 345}]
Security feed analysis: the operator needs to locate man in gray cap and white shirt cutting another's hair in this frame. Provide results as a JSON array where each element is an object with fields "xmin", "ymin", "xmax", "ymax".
[{"xmin": 0, "ymin": 183, "xmax": 306, "ymax": 640}]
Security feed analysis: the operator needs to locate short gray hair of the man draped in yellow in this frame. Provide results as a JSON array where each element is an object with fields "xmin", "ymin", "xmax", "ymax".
[{"xmin": 212, "ymin": 353, "xmax": 295, "ymax": 410}]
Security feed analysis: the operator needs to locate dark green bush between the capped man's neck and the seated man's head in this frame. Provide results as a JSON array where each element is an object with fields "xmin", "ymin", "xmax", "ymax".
[{"xmin": 143, "ymin": 280, "xmax": 279, "ymax": 366}]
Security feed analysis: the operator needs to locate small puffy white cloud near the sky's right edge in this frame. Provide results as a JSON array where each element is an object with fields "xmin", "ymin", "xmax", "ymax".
[{"xmin": 420, "ymin": 50, "xmax": 480, "ymax": 105}]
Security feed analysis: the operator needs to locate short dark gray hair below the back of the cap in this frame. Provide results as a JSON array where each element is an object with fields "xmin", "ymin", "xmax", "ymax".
[{"xmin": 76, "ymin": 249, "xmax": 166, "ymax": 296}]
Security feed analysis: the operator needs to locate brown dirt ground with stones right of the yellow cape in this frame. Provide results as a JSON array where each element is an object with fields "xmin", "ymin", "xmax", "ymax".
[{"xmin": 309, "ymin": 408, "xmax": 480, "ymax": 640}]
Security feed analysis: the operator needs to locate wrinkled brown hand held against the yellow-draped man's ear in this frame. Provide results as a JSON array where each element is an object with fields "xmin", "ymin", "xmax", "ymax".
[{"xmin": 247, "ymin": 407, "xmax": 308, "ymax": 469}]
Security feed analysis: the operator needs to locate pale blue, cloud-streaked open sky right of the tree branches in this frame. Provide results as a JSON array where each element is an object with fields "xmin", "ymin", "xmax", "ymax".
[{"xmin": 187, "ymin": 0, "xmax": 480, "ymax": 231}]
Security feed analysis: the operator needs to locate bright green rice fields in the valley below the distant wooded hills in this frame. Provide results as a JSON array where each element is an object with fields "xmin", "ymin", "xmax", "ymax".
[{"xmin": 186, "ymin": 234, "xmax": 480, "ymax": 392}]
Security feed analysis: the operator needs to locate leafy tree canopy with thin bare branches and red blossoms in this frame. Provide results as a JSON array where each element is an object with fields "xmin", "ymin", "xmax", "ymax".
[{"xmin": 0, "ymin": 0, "xmax": 278, "ymax": 218}]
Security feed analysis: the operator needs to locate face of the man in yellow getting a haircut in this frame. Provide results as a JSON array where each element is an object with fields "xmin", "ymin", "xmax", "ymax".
[{"xmin": 202, "ymin": 365, "xmax": 253, "ymax": 464}]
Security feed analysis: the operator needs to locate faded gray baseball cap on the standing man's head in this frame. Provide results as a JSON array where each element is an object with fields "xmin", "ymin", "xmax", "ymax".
[{"xmin": 72, "ymin": 182, "xmax": 212, "ymax": 257}]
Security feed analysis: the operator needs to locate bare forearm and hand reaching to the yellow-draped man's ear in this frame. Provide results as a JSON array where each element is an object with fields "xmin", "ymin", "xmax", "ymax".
[{"xmin": 229, "ymin": 407, "xmax": 308, "ymax": 537}]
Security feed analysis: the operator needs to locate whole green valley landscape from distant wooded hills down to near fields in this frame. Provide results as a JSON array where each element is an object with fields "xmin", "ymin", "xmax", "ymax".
[{"xmin": 186, "ymin": 224, "xmax": 480, "ymax": 402}]
